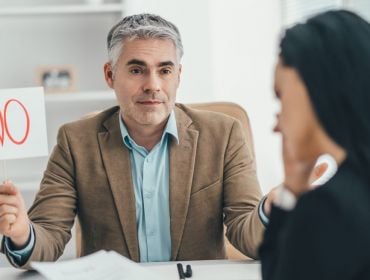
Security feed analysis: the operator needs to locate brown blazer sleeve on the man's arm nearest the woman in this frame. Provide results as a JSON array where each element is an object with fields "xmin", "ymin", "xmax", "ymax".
[{"xmin": 223, "ymin": 118, "xmax": 265, "ymax": 258}]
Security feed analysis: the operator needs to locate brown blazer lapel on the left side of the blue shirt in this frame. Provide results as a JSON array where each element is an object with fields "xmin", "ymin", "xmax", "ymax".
[{"xmin": 98, "ymin": 111, "xmax": 140, "ymax": 262}]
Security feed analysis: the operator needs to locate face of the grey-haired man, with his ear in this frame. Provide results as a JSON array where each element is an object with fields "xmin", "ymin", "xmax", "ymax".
[{"xmin": 104, "ymin": 39, "xmax": 181, "ymax": 128}]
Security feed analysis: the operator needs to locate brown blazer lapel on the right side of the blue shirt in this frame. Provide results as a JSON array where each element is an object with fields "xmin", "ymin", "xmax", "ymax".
[{"xmin": 170, "ymin": 107, "xmax": 199, "ymax": 260}]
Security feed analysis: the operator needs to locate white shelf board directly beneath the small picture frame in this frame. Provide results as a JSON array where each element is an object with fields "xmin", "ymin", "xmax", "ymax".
[{"xmin": 45, "ymin": 90, "xmax": 116, "ymax": 103}]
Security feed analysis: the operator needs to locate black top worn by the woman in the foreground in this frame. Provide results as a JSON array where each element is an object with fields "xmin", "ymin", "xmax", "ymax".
[{"xmin": 260, "ymin": 161, "xmax": 370, "ymax": 280}]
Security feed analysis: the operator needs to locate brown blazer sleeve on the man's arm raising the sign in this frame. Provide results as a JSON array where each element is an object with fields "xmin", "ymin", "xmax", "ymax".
[{"xmin": 6, "ymin": 127, "xmax": 77, "ymax": 269}]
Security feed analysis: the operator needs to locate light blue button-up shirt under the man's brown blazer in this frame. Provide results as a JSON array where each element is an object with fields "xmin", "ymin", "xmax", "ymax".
[{"xmin": 119, "ymin": 112, "xmax": 178, "ymax": 262}]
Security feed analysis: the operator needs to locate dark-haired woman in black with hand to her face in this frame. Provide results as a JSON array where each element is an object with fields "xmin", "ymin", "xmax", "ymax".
[{"xmin": 260, "ymin": 11, "xmax": 370, "ymax": 280}]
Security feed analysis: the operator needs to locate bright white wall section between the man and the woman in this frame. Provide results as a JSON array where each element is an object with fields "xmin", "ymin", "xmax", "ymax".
[{"xmin": 210, "ymin": 0, "xmax": 282, "ymax": 193}]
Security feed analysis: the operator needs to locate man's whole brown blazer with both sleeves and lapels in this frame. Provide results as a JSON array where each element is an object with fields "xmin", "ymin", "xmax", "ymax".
[{"xmin": 3, "ymin": 104, "xmax": 264, "ymax": 267}]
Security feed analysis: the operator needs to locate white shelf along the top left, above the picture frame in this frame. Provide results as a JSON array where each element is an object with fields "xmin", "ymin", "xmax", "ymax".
[{"xmin": 0, "ymin": 4, "xmax": 123, "ymax": 16}]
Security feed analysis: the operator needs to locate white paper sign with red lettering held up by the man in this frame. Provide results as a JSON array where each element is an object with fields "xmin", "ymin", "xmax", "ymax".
[{"xmin": 0, "ymin": 87, "xmax": 48, "ymax": 160}]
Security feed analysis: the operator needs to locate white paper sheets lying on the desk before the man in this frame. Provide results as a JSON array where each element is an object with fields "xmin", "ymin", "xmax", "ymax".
[{"xmin": 31, "ymin": 251, "xmax": 162, "ymax": 280}]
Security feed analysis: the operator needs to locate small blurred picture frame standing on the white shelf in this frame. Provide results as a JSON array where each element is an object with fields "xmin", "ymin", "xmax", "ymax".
[{"xmin": 37, "ymin": 65, "xmax": 76, "ymax": 93}]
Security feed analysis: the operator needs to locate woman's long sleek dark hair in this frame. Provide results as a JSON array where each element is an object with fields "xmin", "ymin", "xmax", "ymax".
[{"xmin": 280, "ymin": 10, "xmax": 370, "ymax": 177}]
